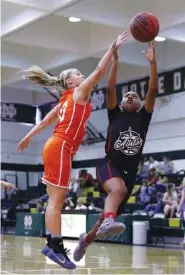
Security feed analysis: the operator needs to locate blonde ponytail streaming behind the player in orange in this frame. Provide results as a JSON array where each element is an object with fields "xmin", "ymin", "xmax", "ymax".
[{"xmin": 22, "ymin": 66, "xmax": 59, "ymax": 86}]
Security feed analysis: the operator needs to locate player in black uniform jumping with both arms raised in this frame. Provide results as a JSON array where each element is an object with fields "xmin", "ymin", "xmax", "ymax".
[{"xmin": 74, "ymin": 41, "xmax": 158, "ymax": 261}]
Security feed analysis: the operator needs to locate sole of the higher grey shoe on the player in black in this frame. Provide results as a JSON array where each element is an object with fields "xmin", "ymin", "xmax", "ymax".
[{"xmin": 96, "ymin": 224, "xmax": 126, "ymax": 239}]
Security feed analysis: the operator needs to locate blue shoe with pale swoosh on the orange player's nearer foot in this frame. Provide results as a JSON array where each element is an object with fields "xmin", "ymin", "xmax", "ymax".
[{"xmin": 47, "ymin": 249, "xmax": 76, "ymax": 269}]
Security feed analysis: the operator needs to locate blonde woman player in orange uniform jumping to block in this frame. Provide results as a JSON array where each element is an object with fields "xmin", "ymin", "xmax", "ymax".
[{"xmin": 18, "ymin": 32, "xmax": 127, "ymax": 269}]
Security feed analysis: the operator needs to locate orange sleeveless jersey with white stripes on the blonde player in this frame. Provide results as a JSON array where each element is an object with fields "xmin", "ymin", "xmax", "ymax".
[{"xmin": 53, "ymin": 88, "xmax": 91, "ymax": 154}]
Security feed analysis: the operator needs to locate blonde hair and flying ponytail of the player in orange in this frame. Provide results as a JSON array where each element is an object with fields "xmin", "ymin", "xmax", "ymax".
[{"xmin": 22, "ymin": 66, "xmax": 76, "ymax": 94}]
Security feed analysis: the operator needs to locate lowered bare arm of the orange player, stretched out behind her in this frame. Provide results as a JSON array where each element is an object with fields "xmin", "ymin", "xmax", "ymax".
[{"xmin": 18, "ymin": 105, "xmax": 58, "ymax": 152}]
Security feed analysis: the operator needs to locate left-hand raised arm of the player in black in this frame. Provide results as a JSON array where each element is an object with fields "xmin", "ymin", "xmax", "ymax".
[{"xmin": 107, "ymin": 49, "xmax": 118, "ymax": 110}]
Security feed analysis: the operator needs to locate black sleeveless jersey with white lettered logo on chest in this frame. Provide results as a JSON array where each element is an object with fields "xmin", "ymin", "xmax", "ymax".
[{"xmin": 105, "ymin": 105, "xmax": 152, "ymax": 172}]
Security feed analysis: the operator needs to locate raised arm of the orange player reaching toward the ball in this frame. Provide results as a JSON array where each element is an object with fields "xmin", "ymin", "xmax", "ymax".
[{"xmin": 74, "ymin": 31, "xmax": 127, "ymax": 101}]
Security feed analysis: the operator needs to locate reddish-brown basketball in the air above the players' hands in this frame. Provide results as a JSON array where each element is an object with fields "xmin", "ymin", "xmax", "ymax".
[{"xmin": 130, "ymin": 12, "xmax": 159, "ymax": 42}]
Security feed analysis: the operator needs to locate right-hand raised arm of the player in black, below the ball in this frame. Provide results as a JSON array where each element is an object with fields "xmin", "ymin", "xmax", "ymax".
[{"xmin": 145, "ymin": 41, "xmax": 158, "ymax": 113}]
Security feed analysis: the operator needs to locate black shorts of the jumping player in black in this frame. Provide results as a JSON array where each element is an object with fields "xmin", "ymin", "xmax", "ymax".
[{"xmin": 96, "ymin": 159, "xmax": 136, "ymax": 214}]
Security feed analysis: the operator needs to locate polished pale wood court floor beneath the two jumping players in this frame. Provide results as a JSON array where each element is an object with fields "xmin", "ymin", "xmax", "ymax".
[{"xmin": 1, "ymin": 235, "xmax": 185, "ymax": 275}]
